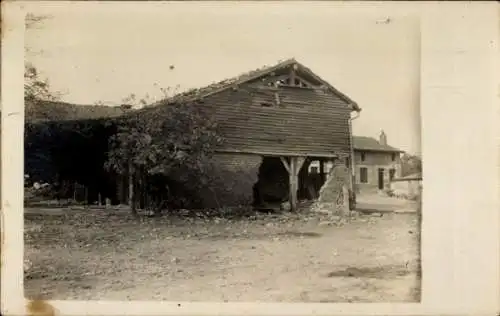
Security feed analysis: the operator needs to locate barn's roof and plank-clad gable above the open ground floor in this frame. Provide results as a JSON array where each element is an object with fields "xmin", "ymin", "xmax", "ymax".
[{"xmin": 134, "ymin": 58, "xmax": 361, "ymax": 157}]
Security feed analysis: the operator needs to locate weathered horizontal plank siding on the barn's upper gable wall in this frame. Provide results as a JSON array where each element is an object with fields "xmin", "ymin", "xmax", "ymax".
[{"xmin": 202, "ymin": 83, "xmax": 350, "ymax": 156}]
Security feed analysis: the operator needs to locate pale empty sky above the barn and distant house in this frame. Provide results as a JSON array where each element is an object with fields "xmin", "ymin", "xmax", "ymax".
[{"xmin": 25, "ymin": 1, "xmax": 420, "ymax": 153}]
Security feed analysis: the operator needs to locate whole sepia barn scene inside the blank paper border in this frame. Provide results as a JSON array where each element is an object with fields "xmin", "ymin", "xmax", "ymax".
[{"xmin": 24, "ymin": 1, "xmax": 424, "ymax": 303}]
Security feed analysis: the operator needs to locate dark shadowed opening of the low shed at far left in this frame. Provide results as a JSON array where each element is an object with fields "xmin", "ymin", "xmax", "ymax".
[{"xmin": 24, "ymin": 119, "xmax": 116, "ymax": 199}]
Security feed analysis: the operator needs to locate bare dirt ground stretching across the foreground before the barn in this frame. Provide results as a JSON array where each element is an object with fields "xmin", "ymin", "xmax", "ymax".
[{"xmin": 24, "ymin": 206, "xmax": 421, "ymax": 302}]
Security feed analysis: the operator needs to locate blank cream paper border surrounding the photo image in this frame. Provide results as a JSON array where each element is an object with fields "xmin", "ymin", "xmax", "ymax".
[{"xmin": 1, "ymin": 1, "xmax": 500, "ymax": 315}]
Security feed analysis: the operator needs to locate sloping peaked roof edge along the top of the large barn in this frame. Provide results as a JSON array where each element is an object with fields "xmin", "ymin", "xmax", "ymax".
[{"xmin": 143, "ymin": 58, "xmax": 361, "ymax": 112}]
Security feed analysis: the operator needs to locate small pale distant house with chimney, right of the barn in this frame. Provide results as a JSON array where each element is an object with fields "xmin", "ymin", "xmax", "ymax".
[{"xmin": 353, "ymin": 131, "xmax": 403, "ymax": 191}]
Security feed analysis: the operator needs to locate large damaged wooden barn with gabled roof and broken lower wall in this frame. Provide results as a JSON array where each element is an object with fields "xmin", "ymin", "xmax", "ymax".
[{"xmin": 137, "ymin": 59, "xmax": 360, "ymax": 214}]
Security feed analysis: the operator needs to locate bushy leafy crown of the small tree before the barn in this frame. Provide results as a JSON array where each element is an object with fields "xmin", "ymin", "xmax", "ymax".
[{"xmin": 106, "ymin": 103, "xmax": 222, "ymax": 183}]
